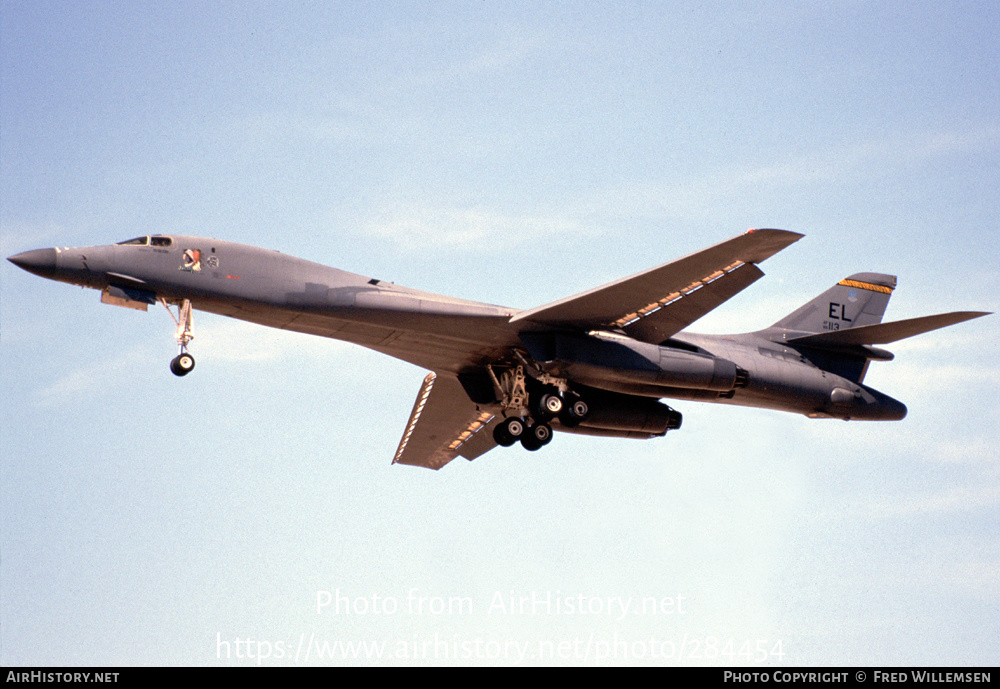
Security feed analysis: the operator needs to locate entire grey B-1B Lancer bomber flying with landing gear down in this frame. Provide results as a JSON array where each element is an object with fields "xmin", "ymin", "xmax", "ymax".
[{"xmin": 9, "ymin": 230, "xmax": 987, "ymax": 469}]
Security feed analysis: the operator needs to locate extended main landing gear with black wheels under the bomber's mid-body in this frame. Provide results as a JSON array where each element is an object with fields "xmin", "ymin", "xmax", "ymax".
[{"xmin": 489, "ymin": 366, "xmax": 590, "ymax": 452}]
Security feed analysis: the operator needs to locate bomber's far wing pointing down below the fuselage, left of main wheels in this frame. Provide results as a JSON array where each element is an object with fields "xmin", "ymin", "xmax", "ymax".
[{"xmin": 392, "ymin": 373, "xmax": 496, "ymax": 469}]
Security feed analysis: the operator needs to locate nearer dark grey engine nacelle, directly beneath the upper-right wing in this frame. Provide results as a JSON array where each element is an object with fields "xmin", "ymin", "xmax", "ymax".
[{"xmin": 521, "ymin": 332, "xmax": 737, "ymax": 392}]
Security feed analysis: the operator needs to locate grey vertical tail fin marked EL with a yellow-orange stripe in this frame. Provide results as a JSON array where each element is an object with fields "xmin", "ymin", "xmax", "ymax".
[{"xmin": 773, "ymin": 273, "xmax": 896, "ymax": 333}]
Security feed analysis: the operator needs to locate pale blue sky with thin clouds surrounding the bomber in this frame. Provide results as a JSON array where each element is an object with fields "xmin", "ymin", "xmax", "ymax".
[{"xmin": 0, "ymin": 0, "xmax": 1000, "ymax": 665}]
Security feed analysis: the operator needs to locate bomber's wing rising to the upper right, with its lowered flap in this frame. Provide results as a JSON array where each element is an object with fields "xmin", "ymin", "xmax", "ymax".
[{"xmin": 511, "ymin": 230, "xmax": 802, "ymax": 343}]
